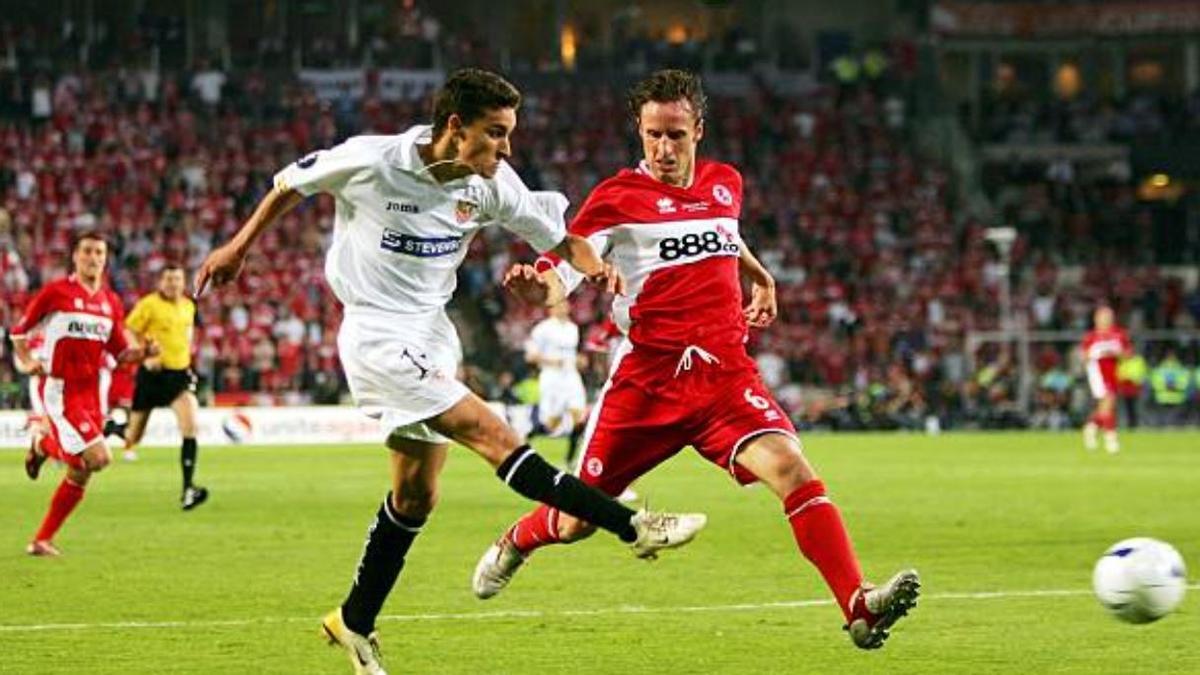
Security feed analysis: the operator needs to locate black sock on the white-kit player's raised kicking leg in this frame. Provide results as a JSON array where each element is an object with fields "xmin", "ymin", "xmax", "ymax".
[{"xmin": 496, "ymin": 444, "xmax": 637, "ymax": 542}]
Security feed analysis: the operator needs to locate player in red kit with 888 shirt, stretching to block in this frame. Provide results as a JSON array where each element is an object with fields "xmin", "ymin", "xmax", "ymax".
[{"xmin": 473, "ymin": 71, "xmax": 919, "ymax": 649}]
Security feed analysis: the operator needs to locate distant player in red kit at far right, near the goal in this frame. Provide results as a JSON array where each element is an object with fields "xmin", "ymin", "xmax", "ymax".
[{"xmin": 1080, "ymin": 306, "xmax": 1133, "ymax": 453}]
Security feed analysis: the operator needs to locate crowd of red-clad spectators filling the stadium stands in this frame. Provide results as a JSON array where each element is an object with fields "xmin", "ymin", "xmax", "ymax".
[{"xmin": 0, "ymin": 61, "xmax": 1200, "ymax": 428}]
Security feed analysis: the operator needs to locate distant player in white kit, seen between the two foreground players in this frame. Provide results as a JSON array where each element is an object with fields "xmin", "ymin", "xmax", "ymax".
[{"xmin": 526, "ymin": 300, "xmax": 588, "ymax": 436}]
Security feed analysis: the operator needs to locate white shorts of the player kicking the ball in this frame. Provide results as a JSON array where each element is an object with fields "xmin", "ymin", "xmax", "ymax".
[{"xmin": 337, "ymin": 307, "xmax": 469, "ymax": 443}]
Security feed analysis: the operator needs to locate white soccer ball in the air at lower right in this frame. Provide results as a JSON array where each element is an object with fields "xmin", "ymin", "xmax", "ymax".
[{"xmin": 1092, "ymin": 537, "xmax": 1187, "ymax": 623}]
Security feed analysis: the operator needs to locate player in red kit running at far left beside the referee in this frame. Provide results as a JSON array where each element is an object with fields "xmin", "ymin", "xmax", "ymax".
[{"xmin": 11, "ymin": 233, "xmax": 152, "ymax": 556}]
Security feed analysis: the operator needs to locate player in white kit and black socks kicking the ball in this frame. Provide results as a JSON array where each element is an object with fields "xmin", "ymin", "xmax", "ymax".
[{"xmin": 196, "ymin": 68, "xmax": 704, "ymax": 675}]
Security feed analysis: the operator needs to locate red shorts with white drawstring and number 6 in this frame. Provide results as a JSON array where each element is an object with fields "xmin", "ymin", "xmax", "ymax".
[{"xmin": 577, "ymin": 343, "xmax": 796, "ymax": 495}]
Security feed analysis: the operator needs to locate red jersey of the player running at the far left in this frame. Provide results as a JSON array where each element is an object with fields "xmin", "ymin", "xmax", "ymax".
[{"xmin": 12, "ymin": 274, "xmax": 128, "ymax": 381}]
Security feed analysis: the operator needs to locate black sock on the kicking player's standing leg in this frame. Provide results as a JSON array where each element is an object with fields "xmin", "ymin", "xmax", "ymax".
[{"xmin": 342, "ymin": 492, "xmax": 425, "ymax": 635}]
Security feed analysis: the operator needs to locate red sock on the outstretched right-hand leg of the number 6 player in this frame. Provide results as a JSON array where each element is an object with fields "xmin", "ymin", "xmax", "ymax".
[{"xmin": 784, "ymin": 480, "xmax": 863, "ymax": 617}]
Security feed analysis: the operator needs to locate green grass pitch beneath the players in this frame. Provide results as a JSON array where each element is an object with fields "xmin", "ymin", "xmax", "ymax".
[{"xmin": 0, "ymin": 432, "xmax": 1200, "ymax": 674}]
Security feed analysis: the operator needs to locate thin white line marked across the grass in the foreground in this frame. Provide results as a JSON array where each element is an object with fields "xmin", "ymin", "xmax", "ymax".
[{"xmin": 0, "ymin": 584, "xmax": 1200, "ymax": 633}]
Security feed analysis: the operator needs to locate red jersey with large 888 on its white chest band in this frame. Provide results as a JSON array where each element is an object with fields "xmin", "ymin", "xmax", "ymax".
[{"xmin": 538, "ymin": 160, "xmax": 746, "ymax": 359}]
